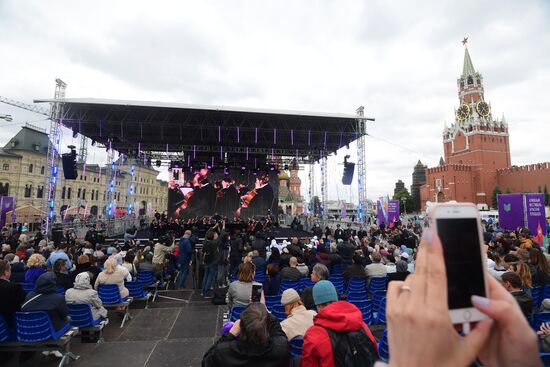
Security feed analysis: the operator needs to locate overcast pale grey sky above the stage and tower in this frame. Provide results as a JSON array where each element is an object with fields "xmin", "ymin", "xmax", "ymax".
[{"xmin": 0, "ymin": 0, "xmax": 550, "ymax": 200}]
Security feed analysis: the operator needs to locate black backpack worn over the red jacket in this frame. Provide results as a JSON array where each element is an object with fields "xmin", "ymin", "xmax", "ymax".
[{"xmin": 324, "ymin": 327, "xmax": 378, "ymax": 367}]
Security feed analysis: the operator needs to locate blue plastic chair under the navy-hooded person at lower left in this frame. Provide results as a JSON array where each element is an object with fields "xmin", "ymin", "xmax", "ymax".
[{"xmin": 15, "ymin": 311, "xmax": 71, "ymax": 343}]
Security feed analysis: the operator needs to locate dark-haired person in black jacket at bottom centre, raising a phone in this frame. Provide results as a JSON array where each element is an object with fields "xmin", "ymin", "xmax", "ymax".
[{"xmin": 202, "ymin": 302, "xmax": 290, "ymax": 367}]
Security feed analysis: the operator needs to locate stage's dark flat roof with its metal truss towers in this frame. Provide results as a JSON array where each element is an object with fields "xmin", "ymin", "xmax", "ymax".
[{"xmin": 34, "ymin": 96, "xmax": 374, "ymax": 224}]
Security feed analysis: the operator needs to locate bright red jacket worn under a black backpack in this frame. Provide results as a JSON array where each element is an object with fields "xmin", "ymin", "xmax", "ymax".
[{"xmin": 300, "ymin": 301, "xmax": 376, "ymax": 367}]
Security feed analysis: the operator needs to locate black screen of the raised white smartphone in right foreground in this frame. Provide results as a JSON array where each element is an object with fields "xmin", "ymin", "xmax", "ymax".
[{"xmin": 436, "ymin": 218, "xmax": 485, "ymax": 310}]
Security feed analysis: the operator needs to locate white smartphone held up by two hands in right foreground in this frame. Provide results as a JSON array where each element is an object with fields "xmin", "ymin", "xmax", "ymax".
[{"xmin": 430, "ymin": 203, "xmax": 488, "ymax": 324}]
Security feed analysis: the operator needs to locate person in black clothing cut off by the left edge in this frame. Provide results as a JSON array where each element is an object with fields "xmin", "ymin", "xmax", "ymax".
[{"xmin": 0, "ymin": 259, "xmax": 25, "ymax": 328}]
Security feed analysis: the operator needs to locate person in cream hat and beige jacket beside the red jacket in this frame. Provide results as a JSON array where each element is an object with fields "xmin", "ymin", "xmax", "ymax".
[{"xmin": 281, "ymin": 288, "xmax": 317, "ymax": 340}]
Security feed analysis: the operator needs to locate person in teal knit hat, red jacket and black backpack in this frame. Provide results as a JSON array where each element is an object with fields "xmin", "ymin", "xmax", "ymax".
[{"xmin": 301, "ymin": 280, "xmax": 378, "ymax": 367}]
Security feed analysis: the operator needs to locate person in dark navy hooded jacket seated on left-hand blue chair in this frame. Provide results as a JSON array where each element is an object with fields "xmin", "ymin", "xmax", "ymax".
[{"xmin": 21, "ymin": 272, "xmax": 69, "ymax": 330}]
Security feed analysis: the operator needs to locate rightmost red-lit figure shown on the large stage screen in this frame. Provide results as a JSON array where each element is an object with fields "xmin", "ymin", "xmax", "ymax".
[{"xmin": 235, "ymin": 173, "xmax": 274, "ymax": 218}]
